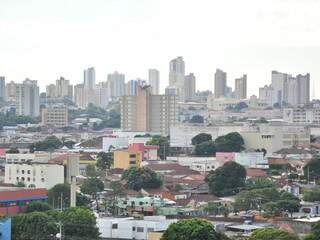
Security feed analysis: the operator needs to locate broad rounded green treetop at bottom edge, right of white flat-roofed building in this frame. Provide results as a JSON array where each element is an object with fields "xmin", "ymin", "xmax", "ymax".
[{"xmin": 161, "ymin": 219, "xmax": 228, "ymax": 240}]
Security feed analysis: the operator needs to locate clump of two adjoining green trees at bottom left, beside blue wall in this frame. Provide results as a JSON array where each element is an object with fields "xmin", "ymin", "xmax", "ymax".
[{"xmin": 12, "ymin": 208, "xmax": 99, "ymax": 240}]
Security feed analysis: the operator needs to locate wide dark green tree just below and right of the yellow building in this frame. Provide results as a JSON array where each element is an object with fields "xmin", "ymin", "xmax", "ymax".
[{"xmin": 122, "ymin": 167, "xmax": 162, "ymax": 191}]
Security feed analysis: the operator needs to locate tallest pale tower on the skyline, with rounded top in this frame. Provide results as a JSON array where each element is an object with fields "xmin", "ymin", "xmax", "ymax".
[{"xmin": 169, "ymin": 57, "xmax": 185, "ymax": 101}]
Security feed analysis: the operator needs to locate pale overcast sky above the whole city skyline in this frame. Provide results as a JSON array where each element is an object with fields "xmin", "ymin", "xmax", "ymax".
[{"xmin": 0, "ymin": 0, "xmax": 320, "ymax": 98}]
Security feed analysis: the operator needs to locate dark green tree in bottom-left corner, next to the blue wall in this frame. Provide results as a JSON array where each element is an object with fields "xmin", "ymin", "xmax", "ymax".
[{"xmin": 12, "ymin": 212, "xmax": 58, "ymax": 240}]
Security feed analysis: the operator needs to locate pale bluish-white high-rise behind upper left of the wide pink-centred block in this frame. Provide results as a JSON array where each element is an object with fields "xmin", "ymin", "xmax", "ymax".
[{"xmin": 108, "ymin": 71, "xmax": 125, "ymax": 98}]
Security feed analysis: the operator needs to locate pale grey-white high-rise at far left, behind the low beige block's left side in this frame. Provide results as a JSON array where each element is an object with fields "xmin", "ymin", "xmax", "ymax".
[{"xmin": 15, "ymin": 79, "xmax": 40, "ymax": 117}]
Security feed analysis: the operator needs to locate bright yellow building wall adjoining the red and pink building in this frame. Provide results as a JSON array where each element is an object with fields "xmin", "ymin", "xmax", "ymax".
[{"xmin": 113, "ymin": 150, "xmax": 142, "ymax": 169}]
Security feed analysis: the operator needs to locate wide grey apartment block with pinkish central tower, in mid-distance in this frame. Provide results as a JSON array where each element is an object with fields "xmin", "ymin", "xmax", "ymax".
[{"xmin": 120, "ymin": 86, "xmax": 178, "ymax": 134}]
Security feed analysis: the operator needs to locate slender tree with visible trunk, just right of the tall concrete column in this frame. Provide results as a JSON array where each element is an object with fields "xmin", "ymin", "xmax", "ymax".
[{"xmin": 80, "ymin": 177, "xmax": 104, "ymax": 211}]
